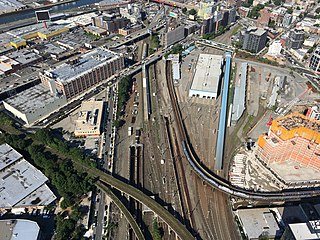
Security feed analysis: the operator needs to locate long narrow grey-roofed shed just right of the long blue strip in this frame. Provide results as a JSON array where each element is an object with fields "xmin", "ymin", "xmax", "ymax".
[{"xmin": 231, "ymin": 63, "xmax": 248, "ymax": 124}]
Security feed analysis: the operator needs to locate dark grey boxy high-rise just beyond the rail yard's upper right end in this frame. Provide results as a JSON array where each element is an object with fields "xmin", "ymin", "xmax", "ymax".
[{"xmin": 241, "ymin": 27, "xmax": 267, "ymax": 53}]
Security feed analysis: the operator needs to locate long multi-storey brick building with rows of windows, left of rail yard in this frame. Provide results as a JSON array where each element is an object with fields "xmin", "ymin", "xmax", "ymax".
[{"xmin": 39, "ymin": 48, "xmax": 124, "ymax": 100}]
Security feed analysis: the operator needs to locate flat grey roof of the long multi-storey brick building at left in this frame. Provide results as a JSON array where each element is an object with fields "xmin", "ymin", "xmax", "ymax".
[{"xmin": 45, "ymin": 48, "xmax": 119, "ymax": 82}]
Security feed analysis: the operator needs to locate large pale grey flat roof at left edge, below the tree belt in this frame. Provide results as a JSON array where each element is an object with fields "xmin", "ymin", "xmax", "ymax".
[{"xmin": 0, "ymin": 159, "xmax": 48, "ymax": 208}]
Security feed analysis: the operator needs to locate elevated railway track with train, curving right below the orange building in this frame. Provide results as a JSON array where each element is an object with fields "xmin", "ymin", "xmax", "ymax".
[{"xmin": 166, "ymin": 56, "xmax": 320, "ymax": 201}]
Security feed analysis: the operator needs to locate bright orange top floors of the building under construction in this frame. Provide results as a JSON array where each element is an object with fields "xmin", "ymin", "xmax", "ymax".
[{"xmin": 271, "ymin": 113, "xmax": 320, "ymax": 144}]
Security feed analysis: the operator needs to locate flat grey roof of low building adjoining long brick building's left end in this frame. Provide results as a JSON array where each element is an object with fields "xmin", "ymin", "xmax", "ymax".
[{"xmin": 4, "ymin": 84, "xmax": 63, "ymax": 113}]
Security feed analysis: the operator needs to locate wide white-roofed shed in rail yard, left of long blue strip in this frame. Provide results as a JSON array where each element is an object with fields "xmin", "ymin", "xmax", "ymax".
[{"xmin": 189, "ymin": 54, "xmax": 223, "ymax": 99}]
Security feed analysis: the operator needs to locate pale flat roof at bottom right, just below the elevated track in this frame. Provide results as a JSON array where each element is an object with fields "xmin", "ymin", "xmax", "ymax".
[{"xmin": 237, "ymin": 208, "xmax": 280, "ymax": 239}]
